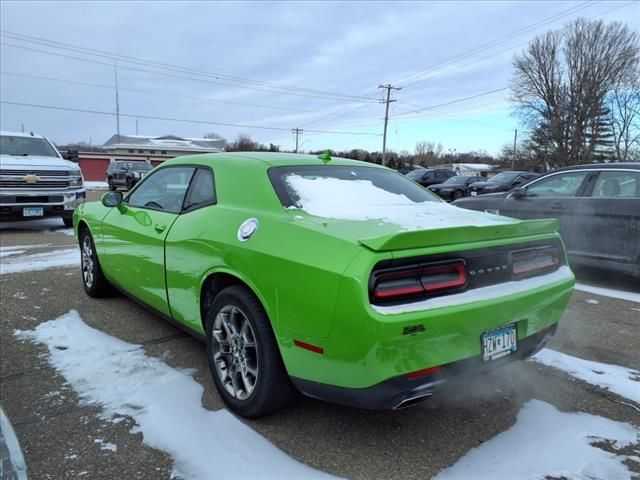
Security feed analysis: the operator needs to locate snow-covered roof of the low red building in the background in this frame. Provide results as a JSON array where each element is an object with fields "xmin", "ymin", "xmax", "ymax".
[{"xmin": 103, "ymin": 134, "xmax": 225, "ymax": 152}]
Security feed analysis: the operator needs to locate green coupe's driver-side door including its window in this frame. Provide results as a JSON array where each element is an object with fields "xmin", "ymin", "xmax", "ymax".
[{"xmin": 101, "ymin": 165, "xmax": 195, "ymax": 315}]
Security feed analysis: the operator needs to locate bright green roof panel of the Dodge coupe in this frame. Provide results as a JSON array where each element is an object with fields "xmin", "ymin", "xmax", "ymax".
[{"xmin": 162, "ymin": 152, "xmax": 385, "ymax": 172}]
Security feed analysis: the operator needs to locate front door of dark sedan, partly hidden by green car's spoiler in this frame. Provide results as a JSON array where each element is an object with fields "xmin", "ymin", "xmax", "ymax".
[{"xmin": 500, "ymin": 170, "xmax": 590, "ymax": 249}]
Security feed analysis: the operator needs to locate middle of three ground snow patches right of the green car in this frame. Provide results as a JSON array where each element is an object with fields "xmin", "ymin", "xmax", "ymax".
[{"xmin": 531, "ymin": 348, "xmax": 640, "ymax": 404}]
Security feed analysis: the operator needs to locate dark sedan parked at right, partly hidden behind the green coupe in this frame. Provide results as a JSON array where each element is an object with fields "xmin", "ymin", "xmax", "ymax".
[{"xmin": 455, "ymin": 163, "xmax": 640, "ymax": 277}]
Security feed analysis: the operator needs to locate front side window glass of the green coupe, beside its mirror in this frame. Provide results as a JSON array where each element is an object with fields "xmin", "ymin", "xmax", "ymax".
[{"xmin": 126, "ymin": 167, "xmax": 195, "ymax": 213}]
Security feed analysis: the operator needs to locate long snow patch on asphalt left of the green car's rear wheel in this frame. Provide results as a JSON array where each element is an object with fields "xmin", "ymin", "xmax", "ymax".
[{"xmin": 16, "ymin": 310, "xmax": 330, "ymax": 480}]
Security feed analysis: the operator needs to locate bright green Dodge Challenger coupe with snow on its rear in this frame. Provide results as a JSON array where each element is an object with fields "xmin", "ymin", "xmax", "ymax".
[{"xmin": 74, "ymin": 153, "xmax": 574, "ymax": 417}]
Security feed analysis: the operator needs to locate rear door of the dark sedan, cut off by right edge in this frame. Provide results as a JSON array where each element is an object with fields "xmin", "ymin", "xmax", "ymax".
[{"xmin": 570, "ymin": 169, "xmax": 640, "ymax": 273}]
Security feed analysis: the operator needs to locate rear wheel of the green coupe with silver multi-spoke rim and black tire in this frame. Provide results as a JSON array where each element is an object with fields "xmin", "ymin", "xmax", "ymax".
[{"xmin": 206, "ymin": 286, "xmax": 294, "ymax": 418}]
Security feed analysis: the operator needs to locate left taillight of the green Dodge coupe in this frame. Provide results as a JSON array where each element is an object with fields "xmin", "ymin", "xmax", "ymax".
[{"xmin": 372, "ymin": 260, "xmax": 467, "ymax": 301}]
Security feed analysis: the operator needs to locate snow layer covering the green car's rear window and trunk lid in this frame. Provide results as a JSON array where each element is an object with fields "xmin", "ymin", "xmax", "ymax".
[{"xmin": 285, "ymin": 175, "xmax": 514, "ymax": 230}]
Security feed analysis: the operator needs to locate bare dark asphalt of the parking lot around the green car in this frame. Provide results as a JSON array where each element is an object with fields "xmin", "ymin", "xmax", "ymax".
[{"xmin": 0, "ymin": 193, "xmax": 640, "ymax": 479}]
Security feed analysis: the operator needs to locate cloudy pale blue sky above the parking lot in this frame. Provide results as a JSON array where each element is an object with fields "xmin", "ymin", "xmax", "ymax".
[{"xmin": 0, "ymin": 0, "xmax": 640, "ymax": 153}]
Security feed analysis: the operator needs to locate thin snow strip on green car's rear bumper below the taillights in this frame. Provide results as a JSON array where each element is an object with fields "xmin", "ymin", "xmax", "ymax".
[{"xmin": 371, "ymin": 266, "xmax": 573, "ymax": 315}]
